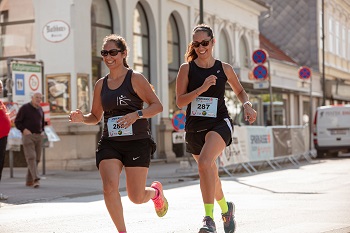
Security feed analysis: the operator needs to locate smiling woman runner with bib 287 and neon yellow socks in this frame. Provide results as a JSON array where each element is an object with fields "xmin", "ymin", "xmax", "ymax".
[{"xmin": 176, "ymin": 24, "xmax": 256, "ymax": 233}]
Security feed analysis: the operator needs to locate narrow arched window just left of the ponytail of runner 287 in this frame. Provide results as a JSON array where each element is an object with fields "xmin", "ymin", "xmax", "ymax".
[{"xmin": 167, "ymin": 14, "xmax": 180, "ymax": 117}]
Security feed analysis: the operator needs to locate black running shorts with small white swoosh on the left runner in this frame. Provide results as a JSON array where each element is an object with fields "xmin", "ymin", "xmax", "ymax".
[{"xmin": 96, "ymin": 138, "xmax": 156, "ymax": 168}]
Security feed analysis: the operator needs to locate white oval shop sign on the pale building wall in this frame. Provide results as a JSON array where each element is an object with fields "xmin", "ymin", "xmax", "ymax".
[{"xmin": 43, "ymin": 20, "xmax": 70, "ymax": 43}]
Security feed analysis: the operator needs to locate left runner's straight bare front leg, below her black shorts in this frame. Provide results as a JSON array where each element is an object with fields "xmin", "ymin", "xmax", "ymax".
[{"xmin": 99, "ymin": 159, "xmax": 126, "ymax": 231}]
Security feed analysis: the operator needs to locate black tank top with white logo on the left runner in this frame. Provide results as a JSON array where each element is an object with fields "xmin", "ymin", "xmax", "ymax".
[{"xmin": 101, "ymin": 69, "xmax": 151, "ymax": 141}]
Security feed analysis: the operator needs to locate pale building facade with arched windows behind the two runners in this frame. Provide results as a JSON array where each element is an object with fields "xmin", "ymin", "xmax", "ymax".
[{"xmin": 0, "ymin": 0, "xmax": 336, "ymax": 170}]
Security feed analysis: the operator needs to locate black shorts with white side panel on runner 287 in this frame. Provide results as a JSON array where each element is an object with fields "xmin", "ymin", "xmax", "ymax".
[{"xmin": 185, "ymin": 118, "xmax": 233, "ymax": 155}]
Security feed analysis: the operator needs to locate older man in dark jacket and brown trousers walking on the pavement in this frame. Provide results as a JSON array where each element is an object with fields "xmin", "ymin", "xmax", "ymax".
[{"xmin": 15, "ymin": 92, "xmax": 45, "ymax": 188}]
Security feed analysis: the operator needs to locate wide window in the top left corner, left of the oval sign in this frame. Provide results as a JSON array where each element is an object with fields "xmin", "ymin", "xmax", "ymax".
[{"xmin": 0, "ymin": 0, "xmax": 36, "ymax": 97}]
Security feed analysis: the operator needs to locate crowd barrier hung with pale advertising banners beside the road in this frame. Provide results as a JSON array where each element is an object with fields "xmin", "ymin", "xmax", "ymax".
[{"xmin": 218, "ymin": 126, "xmax": 311, "ymax": 174}]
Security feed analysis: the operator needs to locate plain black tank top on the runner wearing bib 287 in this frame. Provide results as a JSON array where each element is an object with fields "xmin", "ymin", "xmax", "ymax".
[{"xmin": 185, "ymin": 60, "xmax": 229, "ymax": 132}]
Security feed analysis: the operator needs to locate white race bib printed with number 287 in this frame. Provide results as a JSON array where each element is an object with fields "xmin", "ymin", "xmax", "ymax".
[{"xmin": 191, "ymin": 96, "xmax": 218, "ymax": 117}]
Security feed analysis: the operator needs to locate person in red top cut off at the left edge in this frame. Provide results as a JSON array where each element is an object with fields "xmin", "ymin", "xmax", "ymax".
[{"xmin": 0, "ymin": 80, "xmax": 11, "ymax": 200}]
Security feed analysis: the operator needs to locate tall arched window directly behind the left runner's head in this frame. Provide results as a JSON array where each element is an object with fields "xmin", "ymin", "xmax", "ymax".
[{"xmin": 91, "ymin": 0, "xmax": 113, "ymax": 86}]
